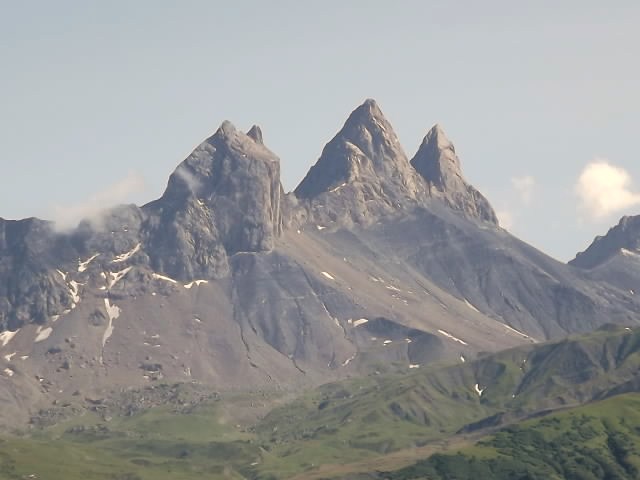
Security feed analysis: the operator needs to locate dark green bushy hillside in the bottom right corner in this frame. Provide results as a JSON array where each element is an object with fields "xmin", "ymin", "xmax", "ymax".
[{"xmin": 380, "ymin": 393, "xmax": 640, "ymax": 480}]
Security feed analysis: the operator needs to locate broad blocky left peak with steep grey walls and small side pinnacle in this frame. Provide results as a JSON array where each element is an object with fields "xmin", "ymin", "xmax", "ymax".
[{"xmin": 144, "ymin": 121, "xmax": 283, "ymax": 279}]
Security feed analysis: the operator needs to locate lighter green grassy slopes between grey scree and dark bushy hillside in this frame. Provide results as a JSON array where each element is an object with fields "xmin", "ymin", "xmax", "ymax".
[{"xmin": 0, "ymin": 328, "xmax": 640, "ymax": 480}]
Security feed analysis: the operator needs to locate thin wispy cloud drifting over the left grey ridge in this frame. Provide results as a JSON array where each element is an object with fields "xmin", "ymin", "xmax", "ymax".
[{"xmin": 49, "ymin": 172, "xmax": 144, "ymax": 231}]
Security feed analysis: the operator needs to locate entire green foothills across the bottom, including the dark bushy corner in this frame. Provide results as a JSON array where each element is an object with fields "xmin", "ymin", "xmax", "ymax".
[{"xmin": 0, "ymin": 327, "xmax": 640, "ymax": 480}]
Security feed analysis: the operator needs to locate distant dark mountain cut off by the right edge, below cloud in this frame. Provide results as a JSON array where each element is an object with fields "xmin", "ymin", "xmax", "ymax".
[{"xmin": 569, "ymin": 216, "xmax": 640, "ymax": 295}]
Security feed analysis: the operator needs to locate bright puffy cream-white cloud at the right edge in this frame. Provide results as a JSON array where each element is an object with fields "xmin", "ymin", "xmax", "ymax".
[{"xmin": 575, "ymin": 159, "xmax": 640, "ymax": 218}]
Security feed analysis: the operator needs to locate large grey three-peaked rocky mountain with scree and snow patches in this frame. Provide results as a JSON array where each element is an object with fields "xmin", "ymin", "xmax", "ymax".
[{"xmin": 0, "ymin": 100, "xmax": 640, "ymax": 426}]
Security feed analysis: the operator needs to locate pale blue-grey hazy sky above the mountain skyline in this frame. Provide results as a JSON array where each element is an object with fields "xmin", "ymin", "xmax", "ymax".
[{"xmin": 0, "ymin": 0, "xmax": 640, "ymax": 261}]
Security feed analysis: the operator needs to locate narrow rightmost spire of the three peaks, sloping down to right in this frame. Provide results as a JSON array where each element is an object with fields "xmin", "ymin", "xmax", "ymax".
[{"xmin": 411, "ymin": 124, "xmax": 498, "ymax": 225}]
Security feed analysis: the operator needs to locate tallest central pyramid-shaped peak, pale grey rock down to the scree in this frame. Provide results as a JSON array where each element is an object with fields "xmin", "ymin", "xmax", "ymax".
[{"xmin": 295, "ymin": 99, "xmax": 426, "ymax": 224}]
